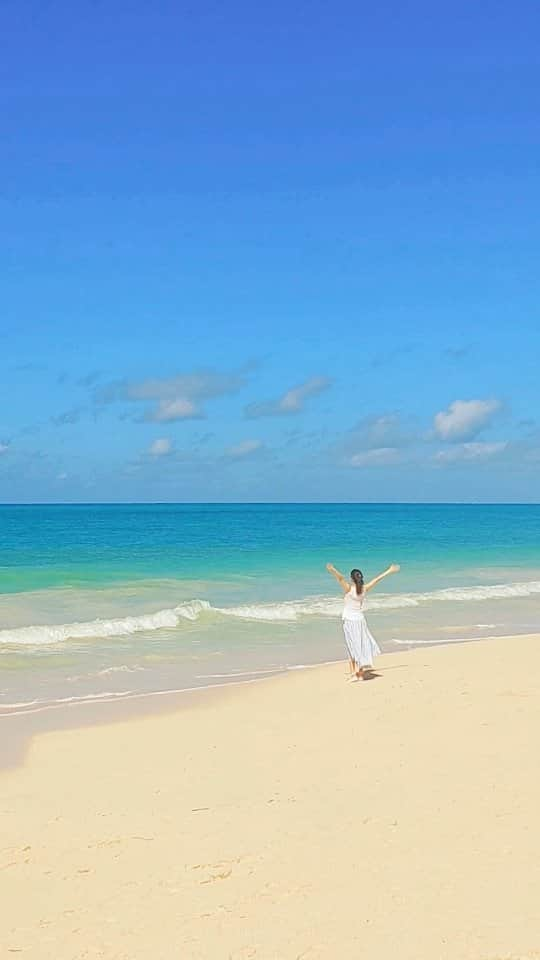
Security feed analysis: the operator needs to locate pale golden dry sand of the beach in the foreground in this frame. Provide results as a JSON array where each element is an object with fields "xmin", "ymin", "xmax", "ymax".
[{"xmin": 0, "ymin": 637, "xmax": 540, "ymax": 960}]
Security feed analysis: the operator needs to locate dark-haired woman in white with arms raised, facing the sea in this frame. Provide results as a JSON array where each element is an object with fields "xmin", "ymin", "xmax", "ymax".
[{"xmin": 326, "ymin": 563, "xmax": 399, "ymax": 680}]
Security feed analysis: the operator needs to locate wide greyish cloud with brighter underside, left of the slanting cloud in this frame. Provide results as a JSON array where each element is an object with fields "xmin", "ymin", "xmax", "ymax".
[{"xmin": 95, "ymin": 370, "xmax": 247, "ymax": 423}]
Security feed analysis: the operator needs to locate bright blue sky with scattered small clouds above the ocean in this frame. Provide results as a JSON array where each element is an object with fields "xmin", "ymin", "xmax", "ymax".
[{"xmin": 0, "ymin": 0, "xmax": 540, "ymax": 502}]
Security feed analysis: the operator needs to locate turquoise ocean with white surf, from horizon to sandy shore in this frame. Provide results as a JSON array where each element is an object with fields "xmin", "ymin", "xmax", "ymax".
[{"xmin": 0, "ymin": 504, "xmax": 540, "ymax": 715}]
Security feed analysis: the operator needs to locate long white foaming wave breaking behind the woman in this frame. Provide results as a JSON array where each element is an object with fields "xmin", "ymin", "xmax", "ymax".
[{"xmin": 0, "ymin": 580, "xmax": 540, "ymax": 646}]
